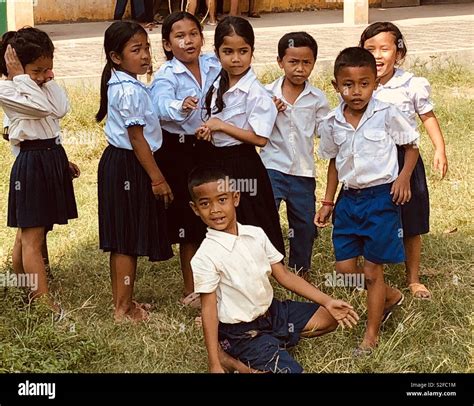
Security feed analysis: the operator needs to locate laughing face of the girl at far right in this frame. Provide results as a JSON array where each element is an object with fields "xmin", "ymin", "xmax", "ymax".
[{"xmin": 364, "ymin": 32, "xmax": 400, "ymax": 84}]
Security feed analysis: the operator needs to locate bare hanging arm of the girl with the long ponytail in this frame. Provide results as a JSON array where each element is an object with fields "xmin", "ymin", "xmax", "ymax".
[{"xmin": 128, "ymin": 125, "xmax": 174, "ymax": 208}]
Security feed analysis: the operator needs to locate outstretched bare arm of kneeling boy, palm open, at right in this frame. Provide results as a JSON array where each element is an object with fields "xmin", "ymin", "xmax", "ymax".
[{"xmin": 272, "ymin": 262, "xmax": 359, "ymax": 328}]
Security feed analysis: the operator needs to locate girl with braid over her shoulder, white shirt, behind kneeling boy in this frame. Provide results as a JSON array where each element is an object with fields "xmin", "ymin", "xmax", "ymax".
[{"xmin": 196, "ymin": 17, "xmax": 285, "ymax": 255}]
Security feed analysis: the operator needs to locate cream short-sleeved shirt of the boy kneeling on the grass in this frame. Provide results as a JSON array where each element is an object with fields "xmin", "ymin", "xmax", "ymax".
[{"xmin": 191, "ymin": 223, "xmax": 283, "ymax": 324}]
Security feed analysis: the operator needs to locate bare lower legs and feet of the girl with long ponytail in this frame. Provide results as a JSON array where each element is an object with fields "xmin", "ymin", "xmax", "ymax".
[{"xmin": 110, "ymin": 252, "xmax": 148, "ymax": 321}]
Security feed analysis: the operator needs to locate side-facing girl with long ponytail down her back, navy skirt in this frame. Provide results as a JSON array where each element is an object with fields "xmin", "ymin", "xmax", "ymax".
[{"xmin": 96, "ymin": 22, "xmax": 173, "ymax": 321}]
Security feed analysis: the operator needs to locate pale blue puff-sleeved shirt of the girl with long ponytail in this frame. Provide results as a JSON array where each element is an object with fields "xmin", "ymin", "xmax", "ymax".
[{"xmin": 105, "ymin": 69, "xmax": 162, "ymax": 152}]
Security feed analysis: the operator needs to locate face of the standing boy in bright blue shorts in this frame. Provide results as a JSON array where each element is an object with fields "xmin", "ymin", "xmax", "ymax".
[{"xmin": 333, "ymin": 66, "xmax": 377, "ymax": 112}]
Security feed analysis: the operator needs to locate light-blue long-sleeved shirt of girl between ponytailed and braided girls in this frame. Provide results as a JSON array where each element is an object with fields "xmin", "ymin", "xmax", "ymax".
[{"xmin": 151, "ymin": 54, "xmax": 221, "ymax": 134}]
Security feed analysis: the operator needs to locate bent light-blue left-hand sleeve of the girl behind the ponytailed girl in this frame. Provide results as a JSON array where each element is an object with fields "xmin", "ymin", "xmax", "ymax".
[{"xmin": 151, "ymin": 72, "xmax": 192, "ymax": 123}]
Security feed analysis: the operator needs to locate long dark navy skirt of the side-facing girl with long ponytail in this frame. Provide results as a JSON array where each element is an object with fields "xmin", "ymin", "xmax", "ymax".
[{"xmin": 98, "ymin": 145, "xmax": 173, "ymax": 261}]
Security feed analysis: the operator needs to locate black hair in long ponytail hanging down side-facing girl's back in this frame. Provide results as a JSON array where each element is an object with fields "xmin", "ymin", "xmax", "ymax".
[{"xmin": 95, "ymin": 21, "xmax": 148, "ymax": 123}]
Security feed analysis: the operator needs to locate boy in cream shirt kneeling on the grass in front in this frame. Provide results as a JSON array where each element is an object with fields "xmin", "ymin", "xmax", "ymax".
[{"xmin": 188, "ymin": 167, "xmax": 359, "ymax": 373}]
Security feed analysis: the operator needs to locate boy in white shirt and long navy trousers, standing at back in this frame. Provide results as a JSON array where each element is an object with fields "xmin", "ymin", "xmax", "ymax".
[{"xmin": 260, "ymin": 32, "xmax": 329, "ymax": 276}]
